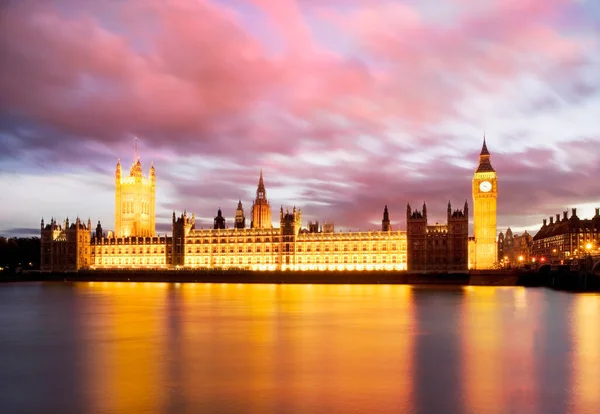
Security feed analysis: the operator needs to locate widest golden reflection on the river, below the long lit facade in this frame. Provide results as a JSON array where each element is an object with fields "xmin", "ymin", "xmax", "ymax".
[{"xmin": 76, "ymin": 283, "xmax": 414, "ymax": 413}]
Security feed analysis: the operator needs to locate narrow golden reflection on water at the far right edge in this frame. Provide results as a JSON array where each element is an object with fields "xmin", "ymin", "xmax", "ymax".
[{"xmin": 570, "ymin": 294, "xmax": 600, "ymax": 414}]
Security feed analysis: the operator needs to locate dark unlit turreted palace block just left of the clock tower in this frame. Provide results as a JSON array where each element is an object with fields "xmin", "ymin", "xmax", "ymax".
[{"xmin": 406, "ymin": 201, "xmax": 469, "ymax": 272}]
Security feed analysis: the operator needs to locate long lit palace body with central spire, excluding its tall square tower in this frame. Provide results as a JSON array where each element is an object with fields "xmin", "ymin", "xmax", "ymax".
[{"xmin": 42, "ymin": 168, "xmax": 407, "ymax": 271}]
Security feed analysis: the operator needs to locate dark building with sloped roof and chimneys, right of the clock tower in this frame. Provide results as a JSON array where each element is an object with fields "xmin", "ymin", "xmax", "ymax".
[{"xmin": 531, "ymin": 208, "xmax": 600, "ymax": 262}]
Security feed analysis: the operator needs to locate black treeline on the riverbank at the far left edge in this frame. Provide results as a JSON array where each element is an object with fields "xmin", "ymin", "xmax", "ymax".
[{"xmin": 0, "ymin": 237, "xmax": 40, "ymax": 272}]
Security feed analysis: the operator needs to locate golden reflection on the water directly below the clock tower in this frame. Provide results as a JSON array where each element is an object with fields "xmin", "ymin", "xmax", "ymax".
[{"xmin": 460, "ymin": 287, "xmax": 539, "ymax": 414}]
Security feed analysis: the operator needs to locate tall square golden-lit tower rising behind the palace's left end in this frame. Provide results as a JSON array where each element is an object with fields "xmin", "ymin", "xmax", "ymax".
[{"xmin": 115, "ymin": 157, "xmax": 156, "ymax": 238}]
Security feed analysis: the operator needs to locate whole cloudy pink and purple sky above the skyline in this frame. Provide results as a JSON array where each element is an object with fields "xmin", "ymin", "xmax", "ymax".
[{"xmin": 0, "ymin": 0, "xmax": 600, "ymax": 235}]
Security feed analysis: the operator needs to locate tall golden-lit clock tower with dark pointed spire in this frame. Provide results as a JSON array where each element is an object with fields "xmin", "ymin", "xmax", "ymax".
[{"xmin": 472, "ymin": 136, "xmax": 498, "ymax": 269}]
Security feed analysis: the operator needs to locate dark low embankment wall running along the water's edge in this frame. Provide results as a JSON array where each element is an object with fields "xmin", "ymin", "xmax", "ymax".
[{"xmin": 0, "ymin": 270, "xmax": 600, "ymax": 292}]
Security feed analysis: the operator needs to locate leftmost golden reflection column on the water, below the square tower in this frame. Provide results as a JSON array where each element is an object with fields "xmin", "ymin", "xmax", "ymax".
[{"xmin": 79, "ymin": 282, "xmax": 168, "ymax": 412}]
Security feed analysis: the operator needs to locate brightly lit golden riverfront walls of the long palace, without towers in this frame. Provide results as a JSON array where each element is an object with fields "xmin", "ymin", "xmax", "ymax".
[{"xmin": 90, "ymin": 229, "xmax": 407, "ymax": 271}]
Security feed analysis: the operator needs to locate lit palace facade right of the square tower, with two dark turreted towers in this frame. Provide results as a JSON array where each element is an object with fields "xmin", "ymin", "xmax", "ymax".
[{"xmin": 173, "ymin": 208, "xmax": 406, "ymax": 270}]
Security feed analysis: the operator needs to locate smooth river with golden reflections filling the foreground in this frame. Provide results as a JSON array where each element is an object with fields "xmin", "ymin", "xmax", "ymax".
[{"xmin": 0, "ymin": 282, "xmax": 600, "ymax": 414}]
